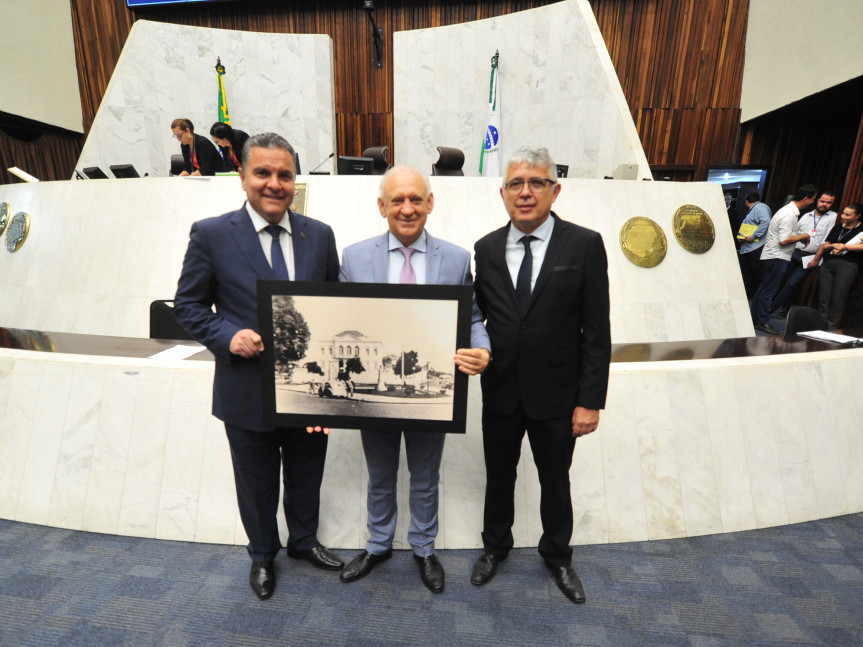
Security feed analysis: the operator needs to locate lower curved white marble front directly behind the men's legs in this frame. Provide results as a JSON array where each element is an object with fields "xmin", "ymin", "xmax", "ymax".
[{"xmin": 0, "ymin": 350, "xmax": 863, "ymax": 549}]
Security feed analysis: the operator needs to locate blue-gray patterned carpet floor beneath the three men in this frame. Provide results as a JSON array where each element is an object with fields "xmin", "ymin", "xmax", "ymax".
[{"xmin": 0, "ymin": 514, "xmax": 863, "ymax": 647}]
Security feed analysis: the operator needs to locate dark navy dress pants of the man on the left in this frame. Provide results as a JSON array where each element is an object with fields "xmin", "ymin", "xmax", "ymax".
[{"xmin": 225, "ymin": 423, "xmax": 327, "ymax": 561}]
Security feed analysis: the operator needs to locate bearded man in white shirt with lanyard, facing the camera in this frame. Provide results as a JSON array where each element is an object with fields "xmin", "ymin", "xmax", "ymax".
[{"xmin": 773, "ymin": 191, "xmax": 836, "ymax": 319}]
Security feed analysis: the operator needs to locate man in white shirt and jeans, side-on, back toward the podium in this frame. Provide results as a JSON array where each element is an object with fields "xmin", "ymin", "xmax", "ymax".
[{"xmin": 749, "ymin": 184, "xmax": 817, "ymax": 335}]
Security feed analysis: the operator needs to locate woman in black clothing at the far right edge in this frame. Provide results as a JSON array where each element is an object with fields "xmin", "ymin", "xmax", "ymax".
[{"xmin": 809, "ymin": 204, "xmax": 863, "ymax": 330}]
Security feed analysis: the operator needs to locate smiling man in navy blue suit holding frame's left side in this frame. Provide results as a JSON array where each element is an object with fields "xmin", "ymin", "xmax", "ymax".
[{"xmin": 174, "ymin": 133, "xmax": 343, "ymax": 600}]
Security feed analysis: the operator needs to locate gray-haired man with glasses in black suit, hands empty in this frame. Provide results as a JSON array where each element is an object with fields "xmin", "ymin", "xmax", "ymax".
[{"xmin": 471, "ymin": 148, "xmax": 611, "ymax": 603}]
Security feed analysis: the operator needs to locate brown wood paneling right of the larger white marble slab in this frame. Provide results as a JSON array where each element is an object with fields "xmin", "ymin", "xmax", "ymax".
[{"xmin": 591, "ymin": 0, "xmax": 749, "ymax": 179}]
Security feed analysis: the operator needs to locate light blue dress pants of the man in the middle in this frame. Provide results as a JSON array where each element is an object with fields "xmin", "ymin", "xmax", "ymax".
[{"xmin": 360, "ymin": 429, "xmax": 446, "ymax": 557}]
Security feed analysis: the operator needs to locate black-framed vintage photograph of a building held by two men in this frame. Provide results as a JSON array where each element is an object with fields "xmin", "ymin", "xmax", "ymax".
[{"xmin": 258, "ymin": 281, "xmax": 473, "ymax": 433}]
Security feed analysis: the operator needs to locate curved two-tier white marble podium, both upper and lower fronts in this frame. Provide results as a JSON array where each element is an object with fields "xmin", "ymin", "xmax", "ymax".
[{"xmin": 0, "ymin": 176, "xmax": 863, "ymax": 548}]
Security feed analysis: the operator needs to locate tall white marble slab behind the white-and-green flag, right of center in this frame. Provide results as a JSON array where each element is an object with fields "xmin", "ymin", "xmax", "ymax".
[{"xmin": 393, "ymin": 0, "xmax": 651, "ymax": 179}]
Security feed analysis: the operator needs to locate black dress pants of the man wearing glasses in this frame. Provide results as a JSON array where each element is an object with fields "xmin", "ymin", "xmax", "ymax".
[{"xmin": 482, "ymin": 403, "xmax": 575, "ymax": 566}]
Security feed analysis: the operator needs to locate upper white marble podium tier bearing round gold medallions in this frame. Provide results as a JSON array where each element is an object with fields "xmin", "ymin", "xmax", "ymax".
[{"xmin": 0, "ymin": 176, "xmax": 753, "ymax": 343}]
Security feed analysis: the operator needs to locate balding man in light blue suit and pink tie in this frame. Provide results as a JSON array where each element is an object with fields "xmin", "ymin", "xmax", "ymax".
[{"xmin": 339, "ymin": 166, "xmax": 491, "ymax": 593}]
